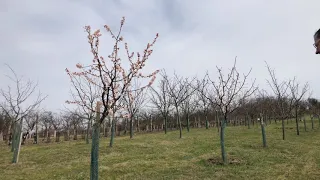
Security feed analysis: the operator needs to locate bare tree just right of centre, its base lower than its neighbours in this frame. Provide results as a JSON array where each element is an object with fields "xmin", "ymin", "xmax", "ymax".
[{"xmin": 165, "ymin": 73, "xmax": 195, "ymax": 138}]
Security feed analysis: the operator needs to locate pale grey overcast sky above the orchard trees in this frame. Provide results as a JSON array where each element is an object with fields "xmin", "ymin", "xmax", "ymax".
[{"xmin": 0, "ymin": 0, "xmax": 320, "ymax": 111}]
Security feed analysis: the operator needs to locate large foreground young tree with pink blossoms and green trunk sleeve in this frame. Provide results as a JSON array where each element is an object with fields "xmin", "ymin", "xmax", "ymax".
[{"xmin": 66, "ymin": 18, "xmax": 158, "ymax": 179}]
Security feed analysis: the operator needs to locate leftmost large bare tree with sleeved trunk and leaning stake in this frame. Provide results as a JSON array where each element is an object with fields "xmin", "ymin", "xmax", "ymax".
[{"xmin": 0, "ymin": 64, "xmax": 47, "ymax": 163}]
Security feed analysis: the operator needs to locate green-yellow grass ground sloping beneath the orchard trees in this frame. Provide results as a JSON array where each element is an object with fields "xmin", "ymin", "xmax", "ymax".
[{"xmin": 0, "ymin": 121, "xmax": 320, "ymax": 180}]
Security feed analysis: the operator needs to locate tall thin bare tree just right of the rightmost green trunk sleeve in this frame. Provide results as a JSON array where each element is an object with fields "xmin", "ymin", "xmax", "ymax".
[{"xmin": 266, "ymin": 63, "xmax": 294, "ymax": 140}]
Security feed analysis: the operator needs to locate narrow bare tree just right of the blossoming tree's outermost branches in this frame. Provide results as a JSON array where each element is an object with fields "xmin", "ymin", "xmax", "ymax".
[{"xmin": 150, "ymin": 71, "xmax": 172, "ymax": 134}]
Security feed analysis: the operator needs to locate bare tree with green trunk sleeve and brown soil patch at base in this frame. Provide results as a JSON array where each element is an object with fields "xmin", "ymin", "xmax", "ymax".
[{"xmin": 208, "ymin": 59, "xmax": 256, "ymax": 164}]
